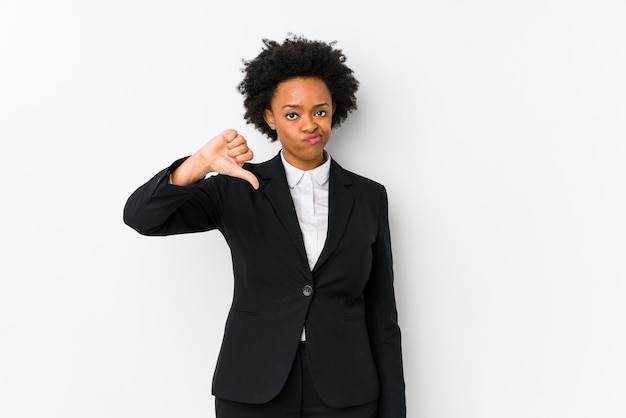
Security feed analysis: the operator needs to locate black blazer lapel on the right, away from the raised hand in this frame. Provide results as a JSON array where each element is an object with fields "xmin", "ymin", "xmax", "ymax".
[{"xmin": 313, "ymin": 160, "xmax": 354, "ymax": 271}]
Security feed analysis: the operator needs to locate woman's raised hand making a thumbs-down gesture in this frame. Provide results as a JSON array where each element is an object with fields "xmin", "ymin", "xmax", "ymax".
[{"xmin": 172, "ymin": 129, "xmax": 259, "ymax": 189}]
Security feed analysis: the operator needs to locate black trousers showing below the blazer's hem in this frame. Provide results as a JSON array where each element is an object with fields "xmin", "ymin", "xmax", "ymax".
[{"xmin": 215, "ymin": 343, "xmax": 378, "ymax": 418}]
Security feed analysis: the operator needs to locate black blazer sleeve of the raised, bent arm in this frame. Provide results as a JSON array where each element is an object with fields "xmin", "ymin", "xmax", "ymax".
[{"xmin": 123, "ymin": 157, "xmax": 227, "ymax": 236}]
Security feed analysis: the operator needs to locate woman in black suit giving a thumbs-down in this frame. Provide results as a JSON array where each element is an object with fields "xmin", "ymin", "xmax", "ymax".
[{"xmin": 124, "ymin": 36, "xmax": 406, "ymax": 418}]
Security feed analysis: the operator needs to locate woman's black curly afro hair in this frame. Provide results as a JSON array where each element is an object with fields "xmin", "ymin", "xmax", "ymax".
[{"xmin": 237, "ymin": 34, "xmax": 359, "ymax": 142}]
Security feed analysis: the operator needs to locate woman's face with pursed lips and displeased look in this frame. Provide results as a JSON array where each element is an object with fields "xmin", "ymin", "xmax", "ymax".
[{"xmin": 265, "ymin": 78, "xmax": 334, "ymax": 170}]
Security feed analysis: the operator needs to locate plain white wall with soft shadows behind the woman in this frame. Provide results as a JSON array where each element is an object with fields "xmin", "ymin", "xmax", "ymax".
[{"xmin": 0, "ymin": 0, "xmax": 626, "ymax": 418}]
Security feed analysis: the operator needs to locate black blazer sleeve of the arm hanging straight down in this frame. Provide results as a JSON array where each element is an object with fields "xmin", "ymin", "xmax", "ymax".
[{"xmin": 365, "ymin": 188, "xmax": 406, "ymax": 418}]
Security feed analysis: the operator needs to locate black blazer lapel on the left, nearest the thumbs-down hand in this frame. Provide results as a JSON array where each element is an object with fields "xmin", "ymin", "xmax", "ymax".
[{"xmin": 258, "ymin": 154, "xmax": 307, "ymax": 262}]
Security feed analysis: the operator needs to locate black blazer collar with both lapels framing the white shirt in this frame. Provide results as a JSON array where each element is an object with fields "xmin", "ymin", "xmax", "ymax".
[{"xmin": 256, "ymin": 153, "xmax": 354, "ymax": 271}]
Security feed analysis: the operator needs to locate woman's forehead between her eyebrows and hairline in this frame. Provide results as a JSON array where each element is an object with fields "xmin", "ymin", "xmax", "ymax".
[{"xmin": 272, "ymin": 78, "xmax": 332, "ymax": 105}]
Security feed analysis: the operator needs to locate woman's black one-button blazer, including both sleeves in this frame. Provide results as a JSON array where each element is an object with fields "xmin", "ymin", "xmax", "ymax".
[{"xmin": 124, "ymin": 155, "xmax": 406, "ymax": 418}]
